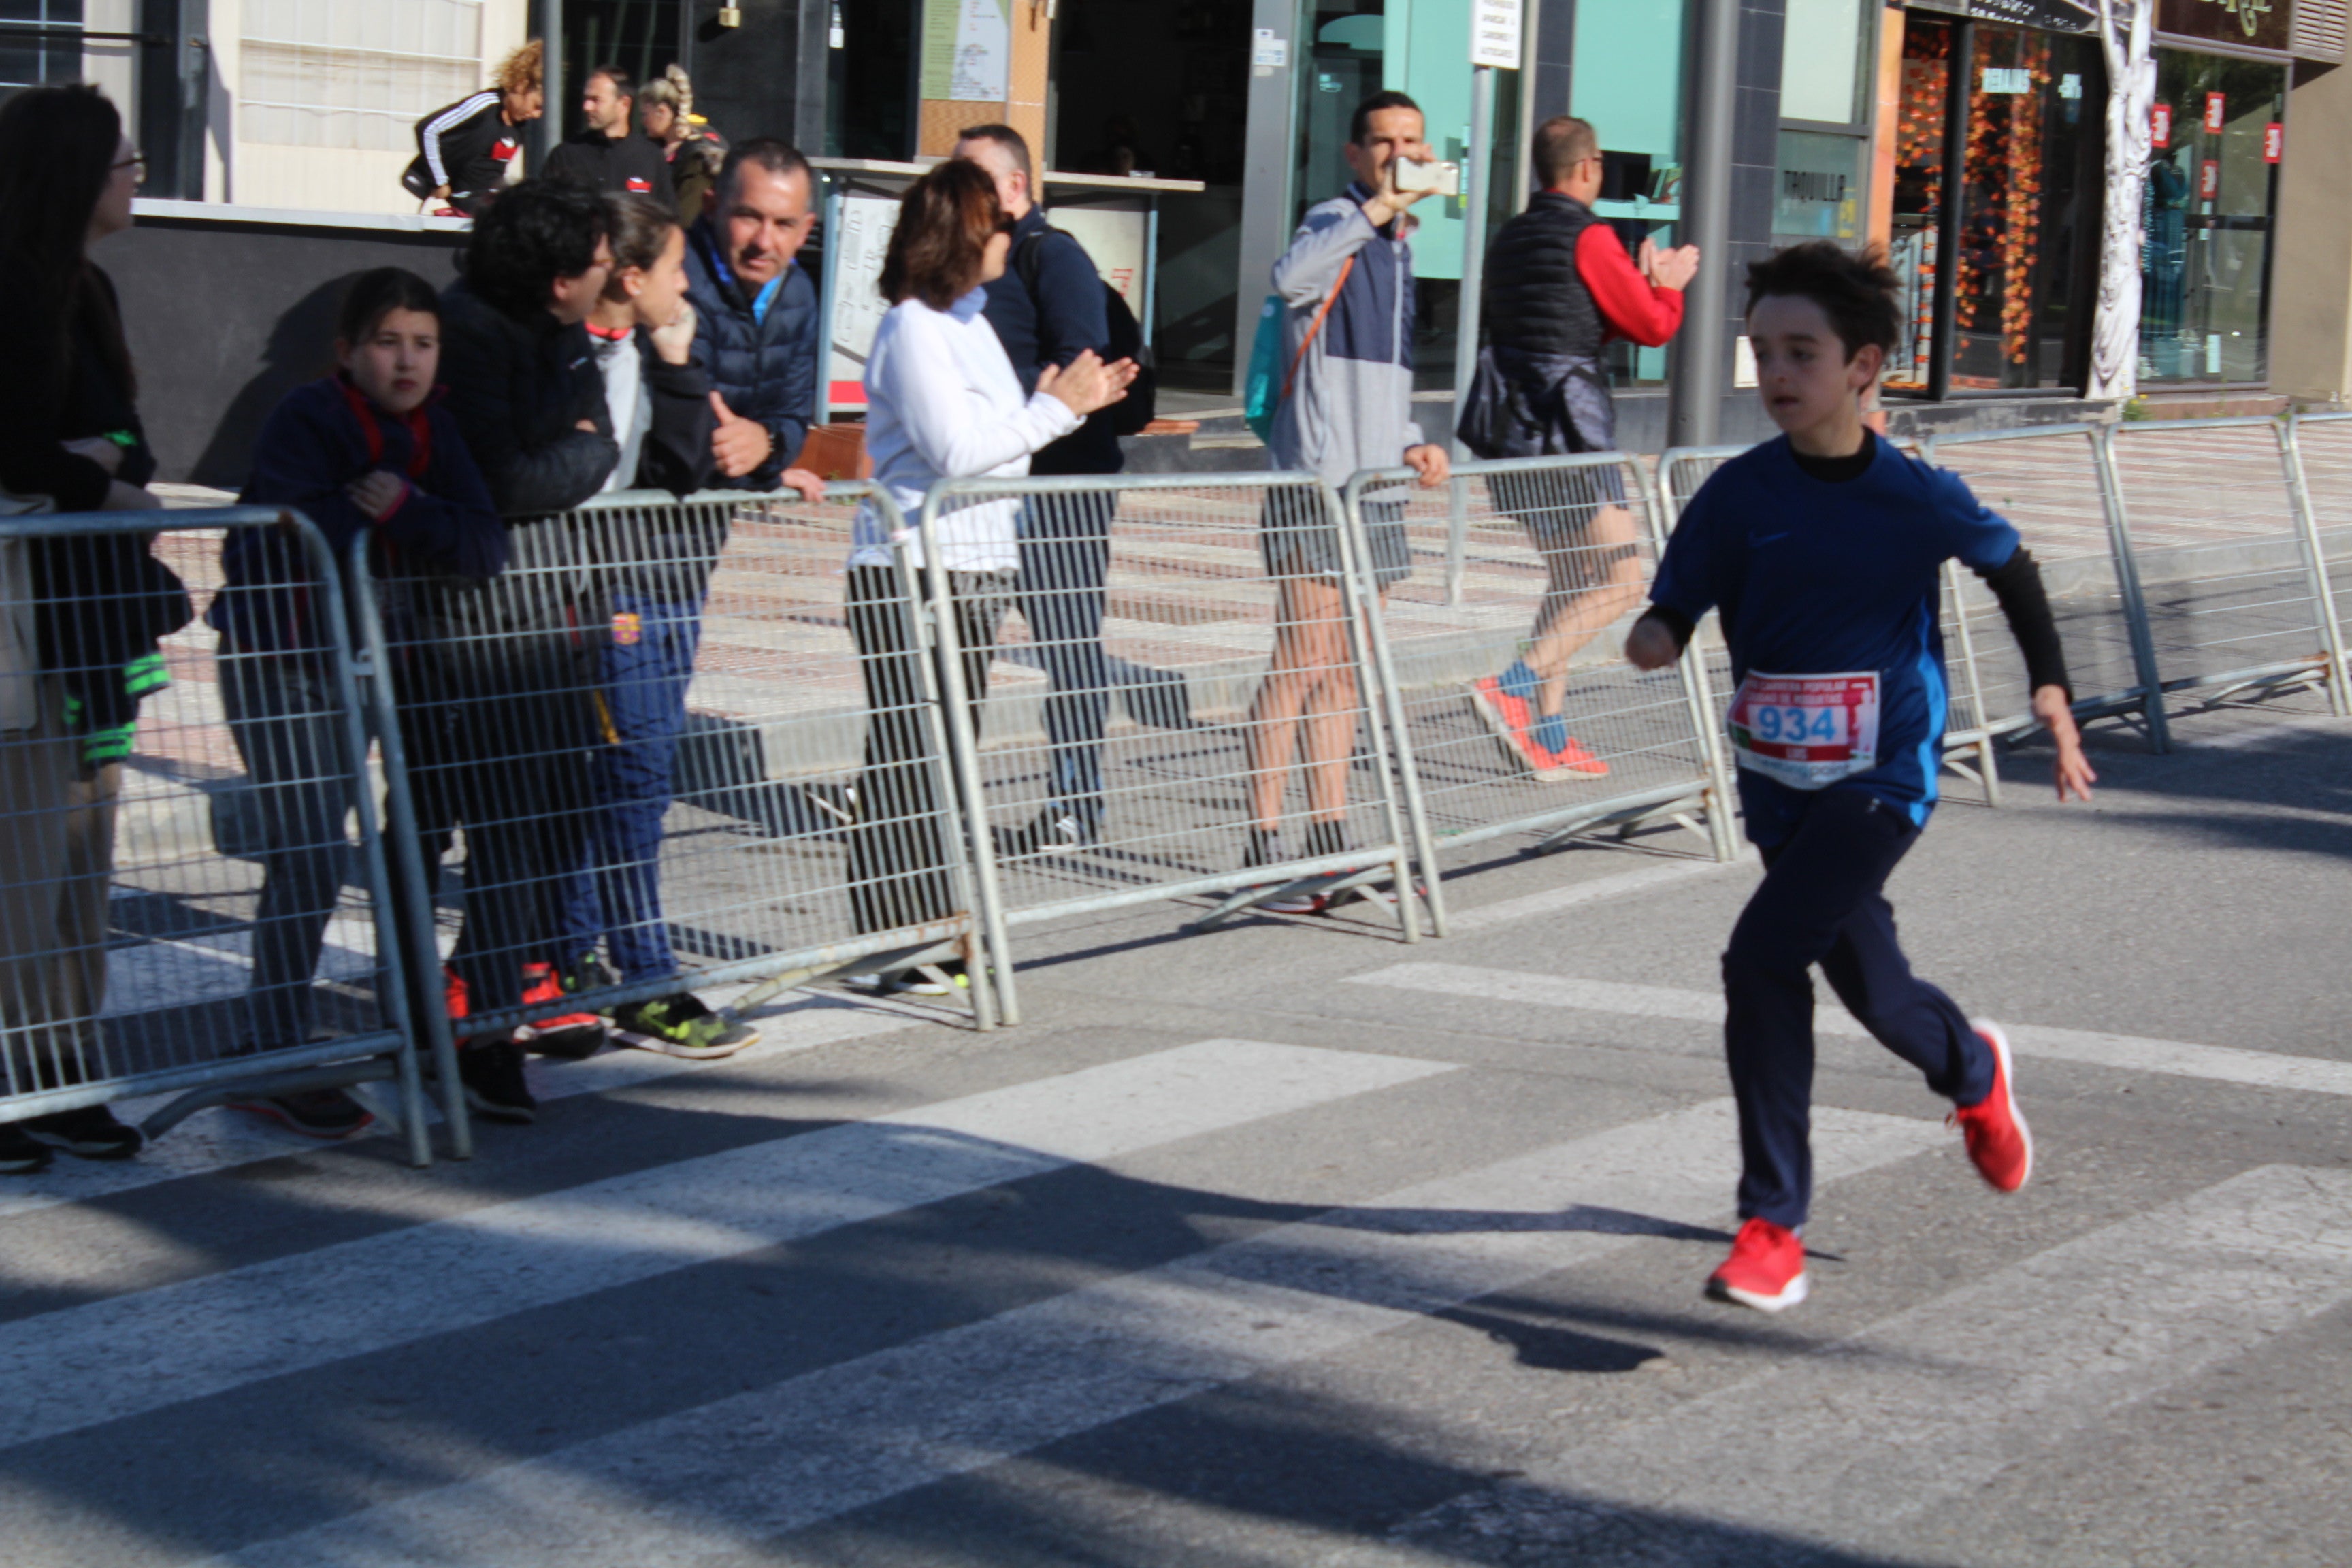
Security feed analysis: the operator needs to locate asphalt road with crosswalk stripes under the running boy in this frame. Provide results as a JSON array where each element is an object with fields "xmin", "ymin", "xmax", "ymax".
[{"xmin": 0, "ymin": 710, "xmax": 2352, "ymax": 1568}]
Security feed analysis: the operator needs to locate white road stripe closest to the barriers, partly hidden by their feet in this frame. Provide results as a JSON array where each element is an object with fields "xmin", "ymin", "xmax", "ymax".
[{"xmin": 0, "ymin": 987, "xmax": 927, "ymax": 1222}]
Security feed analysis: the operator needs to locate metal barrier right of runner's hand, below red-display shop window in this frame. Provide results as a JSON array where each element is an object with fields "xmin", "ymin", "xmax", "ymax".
[{"xmin": 2108, "ymin": 416, "xmax": 2345, "ymax": 713}]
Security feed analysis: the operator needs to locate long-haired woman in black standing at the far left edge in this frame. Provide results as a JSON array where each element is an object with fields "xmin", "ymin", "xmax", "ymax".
[{"xmin": 0, "ymin": 87, "xmax": 193, "ymax": 1173}]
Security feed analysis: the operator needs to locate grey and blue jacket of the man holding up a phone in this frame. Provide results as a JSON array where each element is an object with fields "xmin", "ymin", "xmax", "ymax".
[{"xmin": 1273, "ymin": 183, "xmax": 1428, "ymax": 485}]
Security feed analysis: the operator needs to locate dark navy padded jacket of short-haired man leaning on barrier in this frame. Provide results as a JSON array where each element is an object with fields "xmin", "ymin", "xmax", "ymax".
[{"xmin": 682, "ymin": 219, "xmax": 821, "ymax": 489}]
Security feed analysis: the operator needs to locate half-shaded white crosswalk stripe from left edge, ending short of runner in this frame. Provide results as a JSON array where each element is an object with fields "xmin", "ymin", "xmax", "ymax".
[{"xmin": 0, "ymin": 1039, "xmax": 1454, "ymax": 1448}]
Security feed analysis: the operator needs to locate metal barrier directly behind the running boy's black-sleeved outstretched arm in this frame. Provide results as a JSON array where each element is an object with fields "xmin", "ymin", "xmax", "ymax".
[{"xmin": 1922, "ymin": 423, "xmax": 2166, "ymax": 785}]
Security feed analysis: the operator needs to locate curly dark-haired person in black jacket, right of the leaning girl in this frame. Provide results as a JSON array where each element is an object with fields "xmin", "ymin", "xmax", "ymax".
[{"xmin": 427, "ymin": 179, "xmax": 621, "ymax": 1122}]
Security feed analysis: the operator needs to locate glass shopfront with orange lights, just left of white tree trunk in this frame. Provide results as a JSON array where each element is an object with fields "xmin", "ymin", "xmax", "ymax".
[{"xmin": 1952, "ymin": 24, "xmax": 2103, "ymax": 388}]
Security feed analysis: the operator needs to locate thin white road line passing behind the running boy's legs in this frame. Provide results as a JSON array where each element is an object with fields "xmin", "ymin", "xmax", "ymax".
[{"xmin": 1350, "ymin": 964, "xmax": 2352, "ymax": 1096}]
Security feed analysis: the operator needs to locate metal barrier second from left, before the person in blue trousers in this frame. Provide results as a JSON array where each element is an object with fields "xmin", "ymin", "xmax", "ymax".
[{"xmin": 353, "ymin": 485, "xmax": 995, "ymax": 1072}]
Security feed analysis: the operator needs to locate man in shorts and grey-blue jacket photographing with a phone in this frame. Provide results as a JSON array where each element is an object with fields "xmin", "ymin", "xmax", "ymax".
[{"xmin": 1244, "ymin": 92, "xmax": 1449, "ymax": 912}]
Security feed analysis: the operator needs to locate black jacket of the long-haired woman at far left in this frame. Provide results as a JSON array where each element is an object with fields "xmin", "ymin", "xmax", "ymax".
[{"xmin": 0, "ymin": 265, "xmax": 195, "ymax": 729}]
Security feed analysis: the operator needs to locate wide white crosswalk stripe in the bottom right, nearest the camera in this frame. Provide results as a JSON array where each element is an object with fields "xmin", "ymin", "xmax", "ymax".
[{"xmin": 1397, "ymin": 1166, "xmax": 2352, "ymax": 1561}]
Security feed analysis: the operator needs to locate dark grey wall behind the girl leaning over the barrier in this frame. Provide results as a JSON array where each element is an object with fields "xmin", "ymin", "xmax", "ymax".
[{"xmin": 94, "ymin": 218, "xmax": 466, "ymax": 489}]
